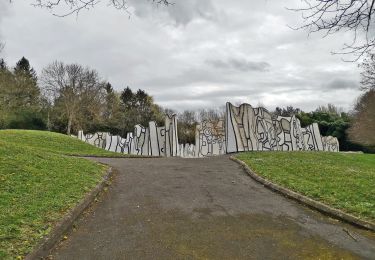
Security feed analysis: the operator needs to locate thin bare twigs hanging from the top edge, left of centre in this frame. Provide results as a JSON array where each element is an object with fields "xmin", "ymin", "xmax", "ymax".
[{"xmin": 29, "ymin": 0, "xmax": 172, "ymax": 17}]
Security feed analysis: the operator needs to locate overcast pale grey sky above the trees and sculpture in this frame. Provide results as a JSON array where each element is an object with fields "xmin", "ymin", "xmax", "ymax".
[{"xmin": 0, "ymin": 0, "xmax": 360, "ymax": 111}]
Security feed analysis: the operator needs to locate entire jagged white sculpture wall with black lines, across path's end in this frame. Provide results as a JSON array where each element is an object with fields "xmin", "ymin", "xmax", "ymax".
[{"xmin": 77, "ymin": 102, "xmax": 339, "ymax": 158}]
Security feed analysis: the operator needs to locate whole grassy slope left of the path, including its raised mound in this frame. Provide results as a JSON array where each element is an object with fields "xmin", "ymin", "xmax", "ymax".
[{"xmin": 0, "ymin": 130, "xmax": 118, "ymax": 259}]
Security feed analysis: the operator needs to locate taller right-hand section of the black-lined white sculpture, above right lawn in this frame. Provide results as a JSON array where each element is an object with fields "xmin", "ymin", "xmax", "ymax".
[{"xmin": 225, "ymin": 103, "xmax": 339, "ymax": 153}]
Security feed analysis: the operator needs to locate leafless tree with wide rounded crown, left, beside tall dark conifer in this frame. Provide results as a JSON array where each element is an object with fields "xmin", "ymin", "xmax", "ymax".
[{"xmin": 41, "ymin": 61, "xmax": 105, "ymax": 135}]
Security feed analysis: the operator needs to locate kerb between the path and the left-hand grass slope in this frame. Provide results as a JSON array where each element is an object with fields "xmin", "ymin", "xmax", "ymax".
[{"xmin": 25, "ymin": 167, "xmax": 113, "ymax": 260}]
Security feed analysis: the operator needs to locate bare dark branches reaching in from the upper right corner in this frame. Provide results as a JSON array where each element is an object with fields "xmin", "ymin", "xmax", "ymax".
[{"xmin": 290, "ymin": 0, "xmax": 375, "ymax": 61}]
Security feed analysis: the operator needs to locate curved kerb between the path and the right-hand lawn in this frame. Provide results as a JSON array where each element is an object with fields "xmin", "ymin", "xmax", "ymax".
[{"xmin": 229, "ymin": 156, "xmax": 375, "ymax": 231}]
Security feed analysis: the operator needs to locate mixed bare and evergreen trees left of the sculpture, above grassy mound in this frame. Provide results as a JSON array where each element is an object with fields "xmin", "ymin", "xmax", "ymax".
[{"xmin": 0, "ymin": 57, "xmax": 165, "ymax": 135}]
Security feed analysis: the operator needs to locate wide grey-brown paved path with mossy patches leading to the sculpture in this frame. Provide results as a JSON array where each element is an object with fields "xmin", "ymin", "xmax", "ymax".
[{"xmin": 52, "ymin": 157, "xmax": 375, "ymax": 260}]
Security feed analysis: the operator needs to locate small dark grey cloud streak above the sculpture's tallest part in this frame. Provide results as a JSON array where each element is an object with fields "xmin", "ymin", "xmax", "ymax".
[{"xmin": 206, "ymin": 58, "xmax": 271, "ymax": 72}]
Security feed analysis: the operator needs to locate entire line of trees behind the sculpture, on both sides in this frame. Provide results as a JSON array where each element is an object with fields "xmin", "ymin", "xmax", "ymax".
[{"xmin": 0, "ymin": 56, "xmax": 375, "ymax": 152}]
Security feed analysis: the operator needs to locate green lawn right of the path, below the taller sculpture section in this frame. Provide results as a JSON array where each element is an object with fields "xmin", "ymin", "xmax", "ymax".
[{"xmin": 236, "ymin": 152, "xmax": 375, "ymax": 221}]
